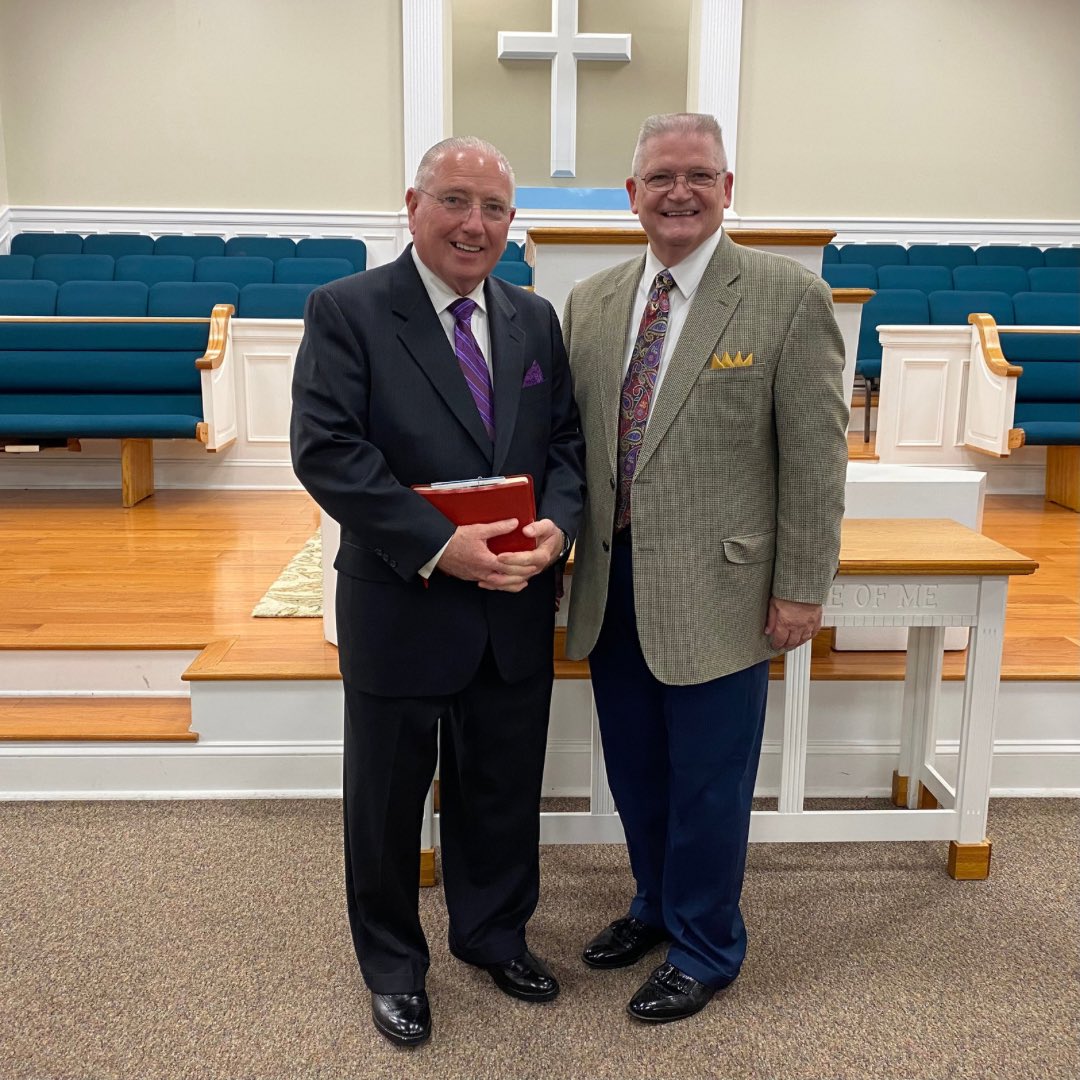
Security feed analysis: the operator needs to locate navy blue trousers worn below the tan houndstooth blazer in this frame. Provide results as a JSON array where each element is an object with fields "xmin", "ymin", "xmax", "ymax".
[{"xmin": 589, "ymin": 543, "xmax": 769, "ymax": 987}]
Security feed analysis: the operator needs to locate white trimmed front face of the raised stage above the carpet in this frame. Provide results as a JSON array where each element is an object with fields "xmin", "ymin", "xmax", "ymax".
[{"xmin": 0, "ymin": 680, "xmax": 1080, "ymax": 803}]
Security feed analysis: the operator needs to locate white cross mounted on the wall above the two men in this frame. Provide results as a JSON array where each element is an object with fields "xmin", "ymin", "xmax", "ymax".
[{"xmin": 499, "ymin": 0, "xmax": 630, "ymax": 176}]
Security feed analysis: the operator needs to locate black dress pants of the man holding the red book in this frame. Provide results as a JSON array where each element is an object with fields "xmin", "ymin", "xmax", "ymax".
[{"xmin": 342, "ymin": 635, "xmax": 552, "ymax": 994}]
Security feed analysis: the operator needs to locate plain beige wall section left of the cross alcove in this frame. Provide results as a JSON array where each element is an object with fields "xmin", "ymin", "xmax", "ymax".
[{"xmin": 0, "ymin": 0, "xmax": 405, "ymax": 210}]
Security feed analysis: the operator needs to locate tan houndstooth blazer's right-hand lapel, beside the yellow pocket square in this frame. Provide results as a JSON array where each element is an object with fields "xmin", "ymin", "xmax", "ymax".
[{"xmin": 637, "ymin": 233, "xmax": 742, "ymax": 473}]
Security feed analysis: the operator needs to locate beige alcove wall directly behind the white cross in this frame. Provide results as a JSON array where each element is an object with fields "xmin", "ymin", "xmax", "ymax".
[{"xmin": 453, "ymin": 0, "xmax": 690, "ymax": 187}]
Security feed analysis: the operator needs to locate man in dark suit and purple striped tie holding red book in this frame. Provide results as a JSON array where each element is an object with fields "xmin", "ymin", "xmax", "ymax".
[{"xmin": 293, "ymin": 132, "xmax": 583, "ymax": 1045}]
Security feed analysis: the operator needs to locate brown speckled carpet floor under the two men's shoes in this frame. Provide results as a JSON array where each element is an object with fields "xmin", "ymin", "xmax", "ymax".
[{"xmin": 0, "ymin": 799, "xmax": 1080, "ymax": 1080}]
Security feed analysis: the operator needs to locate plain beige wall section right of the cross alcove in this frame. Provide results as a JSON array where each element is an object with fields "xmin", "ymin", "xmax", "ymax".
[{"xmin": 734, "ymin": 0, "xmax": 1080, "ymax": 219}]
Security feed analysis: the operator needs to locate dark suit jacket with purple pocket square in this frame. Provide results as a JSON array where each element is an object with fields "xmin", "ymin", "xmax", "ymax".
[{"xmin": 292, "ymin": 249, "xmax": 584, "ymax": 697}]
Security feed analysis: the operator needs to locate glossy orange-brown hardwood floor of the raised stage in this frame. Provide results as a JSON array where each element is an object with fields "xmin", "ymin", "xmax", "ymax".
[{"xmin": 0, "ymin": 490, "xmax": 1080, "ymax": 679}]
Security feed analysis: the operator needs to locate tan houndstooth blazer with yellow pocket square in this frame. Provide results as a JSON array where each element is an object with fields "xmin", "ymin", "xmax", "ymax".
[{"xmin": 563, "ymin": 235, "xmax": 848, "ymax": 685}]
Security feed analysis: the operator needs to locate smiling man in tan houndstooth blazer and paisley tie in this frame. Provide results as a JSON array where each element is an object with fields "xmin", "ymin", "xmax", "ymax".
[{"xmin": 563, "ymin": 113, "xmax": 848, "ymax": 1022}]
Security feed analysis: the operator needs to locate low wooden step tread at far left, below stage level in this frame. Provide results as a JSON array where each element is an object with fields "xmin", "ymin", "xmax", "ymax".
[{"xmin": 0, "ymin": 698, "xmax": 199, "ymax": 742}]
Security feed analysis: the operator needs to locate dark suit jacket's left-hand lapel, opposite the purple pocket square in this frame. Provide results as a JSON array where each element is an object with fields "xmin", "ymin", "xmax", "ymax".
[{"xmin": 393, "ymin": 247, "xmax": 499, "ymax": 457}]
